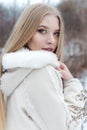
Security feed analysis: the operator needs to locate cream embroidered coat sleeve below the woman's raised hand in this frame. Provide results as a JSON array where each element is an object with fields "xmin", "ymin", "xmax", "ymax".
[{"xmin": 64, "ymin": 78, "xmax": 85, "ymax": 130}]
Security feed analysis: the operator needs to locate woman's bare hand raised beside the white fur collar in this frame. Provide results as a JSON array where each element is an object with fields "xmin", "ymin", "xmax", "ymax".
[{"xmin": 56, "ymin": 62, "xmax": 73, "ymax": 80}]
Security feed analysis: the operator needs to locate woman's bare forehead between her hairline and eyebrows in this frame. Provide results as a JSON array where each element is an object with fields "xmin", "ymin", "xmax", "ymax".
[{"xmin": 40, "ymin": 15, "xmax": 59, "ymax": 29}]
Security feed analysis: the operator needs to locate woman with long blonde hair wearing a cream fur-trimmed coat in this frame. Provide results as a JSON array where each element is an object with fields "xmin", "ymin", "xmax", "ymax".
[{"xmin": 0, "ymin": 4, "xmax": 84, "ymax": 130}]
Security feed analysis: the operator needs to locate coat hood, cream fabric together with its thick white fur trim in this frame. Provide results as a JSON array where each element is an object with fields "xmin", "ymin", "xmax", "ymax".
[{"xmin": 0, "ymin": 48, "xmax": 59, "ymax": 96}]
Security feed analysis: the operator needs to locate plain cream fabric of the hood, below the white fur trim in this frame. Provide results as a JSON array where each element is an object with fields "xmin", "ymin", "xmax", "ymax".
[{"xmin": 0, "ymin": 68, "xmax": 31, "ymax": 96}]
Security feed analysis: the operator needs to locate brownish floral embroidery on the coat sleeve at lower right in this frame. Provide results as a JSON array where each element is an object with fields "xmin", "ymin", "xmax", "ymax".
[{"xmin": 68, "ymin": 91, "xmax": 87, "ymax": 128}]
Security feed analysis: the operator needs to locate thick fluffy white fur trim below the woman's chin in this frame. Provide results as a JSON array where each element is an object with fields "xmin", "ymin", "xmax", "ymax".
[{"xmin": 2, "ymin": 48, "xmax": 59, "ymax": 69}]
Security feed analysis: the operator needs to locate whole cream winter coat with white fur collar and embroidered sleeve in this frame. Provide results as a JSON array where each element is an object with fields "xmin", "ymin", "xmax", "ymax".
[{"xmin": 1, "ymin": 49, "xmax": 84, "ymax": 130}]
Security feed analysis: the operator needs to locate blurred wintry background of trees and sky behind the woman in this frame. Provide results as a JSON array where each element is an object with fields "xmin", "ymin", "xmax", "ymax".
[{"xmin": 0, "ymin": 0, "xmax": 87, "ymax": 88}]
